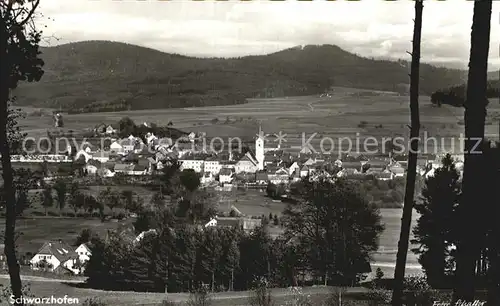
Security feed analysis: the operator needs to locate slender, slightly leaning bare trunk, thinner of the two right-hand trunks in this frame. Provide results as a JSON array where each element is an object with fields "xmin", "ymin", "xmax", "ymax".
[{"xmin": 392, "ymin": 0, "xmax": 424, "ymax": 306}]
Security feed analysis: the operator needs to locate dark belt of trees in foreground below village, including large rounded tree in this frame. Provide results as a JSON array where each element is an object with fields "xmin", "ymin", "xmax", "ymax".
[{"xmin": 82, "ymin": 176, "xmax": 384, "ymax": 292}]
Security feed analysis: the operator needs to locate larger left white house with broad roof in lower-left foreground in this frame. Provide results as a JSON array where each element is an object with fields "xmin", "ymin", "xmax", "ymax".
[{"xmin": 30, "ymin": 241, "xmax": 81, "ymax": 274}]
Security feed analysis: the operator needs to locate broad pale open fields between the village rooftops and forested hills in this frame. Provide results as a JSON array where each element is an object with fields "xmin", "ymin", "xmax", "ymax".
[{"xmin": 21, "ymin": 88, "xmax": 500, "ymax": 152}]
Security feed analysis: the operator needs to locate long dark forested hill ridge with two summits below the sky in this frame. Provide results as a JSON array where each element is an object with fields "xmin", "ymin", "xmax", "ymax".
[{"xmin": 16, "ymin": 41, "xmax": 463, "ymax": 111}]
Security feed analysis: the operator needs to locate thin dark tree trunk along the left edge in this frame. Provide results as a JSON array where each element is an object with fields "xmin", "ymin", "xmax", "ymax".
[{"xmin": 0, "ymin": 16, "xmax": 23, "ymax": 305}]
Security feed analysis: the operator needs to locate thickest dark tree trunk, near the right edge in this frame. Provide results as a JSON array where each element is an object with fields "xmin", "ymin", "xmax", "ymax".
[{"xmin": 453, "ymin": 0, "xmax": 496, "ymax": 302}]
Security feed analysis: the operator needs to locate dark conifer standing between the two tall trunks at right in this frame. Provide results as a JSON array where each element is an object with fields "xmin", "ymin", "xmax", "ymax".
[{"xmin": 412, "ymin": 155, "xmax": 463, "ymax": 286}]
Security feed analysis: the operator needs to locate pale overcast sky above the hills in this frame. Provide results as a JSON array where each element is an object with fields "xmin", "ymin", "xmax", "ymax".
[{"xmin": 39, "ymin": 0, "xmax": 500, "ymax": 69}]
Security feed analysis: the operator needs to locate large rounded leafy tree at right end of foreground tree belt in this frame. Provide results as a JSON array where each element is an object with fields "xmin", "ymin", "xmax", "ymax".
[{"xmin": 283, "ymin": 180, "xmax": 384, "ymax": 285}]
